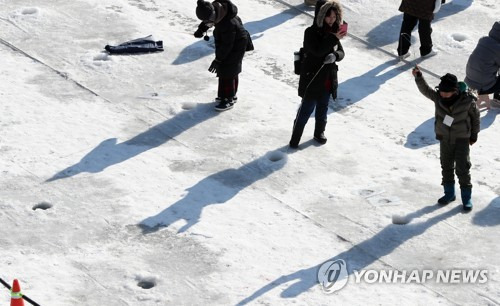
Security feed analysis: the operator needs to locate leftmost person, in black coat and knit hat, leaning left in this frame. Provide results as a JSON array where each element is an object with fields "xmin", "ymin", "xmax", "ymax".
[{"xmin": 194, "ymin": 0, "xmax": 253, "ymax": 111}]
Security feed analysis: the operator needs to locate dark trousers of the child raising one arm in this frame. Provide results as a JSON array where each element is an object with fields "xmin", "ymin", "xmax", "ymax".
[{"xmin": 439, "ymin": 139, "xmax": 472, "ymax": 188}]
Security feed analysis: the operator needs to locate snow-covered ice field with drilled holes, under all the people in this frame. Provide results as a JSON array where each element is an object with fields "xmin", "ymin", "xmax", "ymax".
[{"xmin": 0, "ymin": 0, "xmax": 500, "ymax": 306}]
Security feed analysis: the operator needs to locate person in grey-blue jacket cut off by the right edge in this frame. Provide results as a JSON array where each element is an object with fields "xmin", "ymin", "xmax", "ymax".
[{"xmin": 465, "ymin": 21, "xmax": 500, "ymax": 108}]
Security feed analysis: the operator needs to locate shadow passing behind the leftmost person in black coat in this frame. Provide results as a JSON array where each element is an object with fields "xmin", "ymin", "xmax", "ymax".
[{"xmin": 172, "ymin": 4, "xmax": 304, "ymax": 65}]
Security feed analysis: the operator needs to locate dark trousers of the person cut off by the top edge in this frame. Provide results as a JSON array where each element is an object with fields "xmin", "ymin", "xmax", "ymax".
[{"xmin": 398, "ymin": 13, "xmax": 432, "ymax": 56}]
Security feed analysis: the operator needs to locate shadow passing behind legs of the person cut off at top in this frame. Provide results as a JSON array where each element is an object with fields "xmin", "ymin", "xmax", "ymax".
[{"xmin": 366, "ymin": 0, "xmax": 473, "ymax": 47}]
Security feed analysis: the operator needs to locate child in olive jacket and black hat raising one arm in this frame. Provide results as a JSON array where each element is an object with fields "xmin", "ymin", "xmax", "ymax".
[{"xmin": 412, "ymin": 66, "xmax": 480, "ymax": 210}]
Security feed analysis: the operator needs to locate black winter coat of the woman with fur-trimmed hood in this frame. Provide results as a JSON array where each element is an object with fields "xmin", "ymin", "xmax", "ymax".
[{"xmin": 299, "ymin": 23, "xmax": 344, "ymax": 99}]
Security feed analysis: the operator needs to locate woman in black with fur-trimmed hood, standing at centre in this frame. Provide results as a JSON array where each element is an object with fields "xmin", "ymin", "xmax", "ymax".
[{"xmin": 290, "ymin": 0, "xmax": 347, "ymax": 149}]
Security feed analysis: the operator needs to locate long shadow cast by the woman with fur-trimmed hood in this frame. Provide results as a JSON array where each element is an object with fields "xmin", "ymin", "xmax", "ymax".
[{"xmin": 138, "ymin": 140, "xmax": 313, "ymax": 234}]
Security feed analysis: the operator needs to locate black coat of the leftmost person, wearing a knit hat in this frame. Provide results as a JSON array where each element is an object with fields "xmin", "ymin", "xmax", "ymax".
[{"xmin": 214, "ymin": 1, "xmax": 248, "ymax": 78}]
